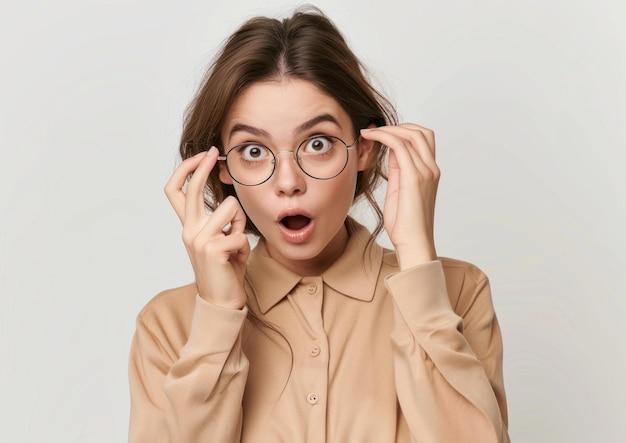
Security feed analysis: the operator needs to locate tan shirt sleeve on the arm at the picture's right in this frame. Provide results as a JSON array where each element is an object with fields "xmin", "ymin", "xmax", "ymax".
[{"xmin": 385, "ymin": 261, "xmax": 509, "ymax": 442}]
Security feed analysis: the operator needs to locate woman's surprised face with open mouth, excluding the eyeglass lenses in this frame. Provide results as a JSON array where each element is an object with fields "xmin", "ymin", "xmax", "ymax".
[{"xmin": 220, "ymin": 78, "xmax": 372, "ymax": 275}]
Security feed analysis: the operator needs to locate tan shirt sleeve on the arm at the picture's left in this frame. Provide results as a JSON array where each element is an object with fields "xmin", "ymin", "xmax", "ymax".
[{"xmin": 129, "ymin": 296, "xmax": 248, "ymax": 443}]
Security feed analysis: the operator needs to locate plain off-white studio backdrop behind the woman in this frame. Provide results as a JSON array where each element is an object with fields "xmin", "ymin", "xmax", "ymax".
[{"xmin": 0, "ymin": 0, "xmax": 626, "ymax": 443}]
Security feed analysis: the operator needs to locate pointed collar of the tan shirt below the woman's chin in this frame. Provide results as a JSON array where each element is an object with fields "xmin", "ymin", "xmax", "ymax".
[{"xmin": 246, "ymin": 223, "xmax": 383, "ymax": 314}]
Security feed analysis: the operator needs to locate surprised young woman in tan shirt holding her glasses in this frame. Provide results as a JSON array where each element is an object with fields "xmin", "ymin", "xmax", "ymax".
[{"xmin": 130, "ymin": 6, "xmax": 508, "ymax": 443}]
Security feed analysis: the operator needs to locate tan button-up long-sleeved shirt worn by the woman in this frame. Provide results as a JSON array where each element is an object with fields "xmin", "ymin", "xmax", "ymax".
[{"xmin": 129, "ymin": 224, "xmax": 509, "ymax": 443}]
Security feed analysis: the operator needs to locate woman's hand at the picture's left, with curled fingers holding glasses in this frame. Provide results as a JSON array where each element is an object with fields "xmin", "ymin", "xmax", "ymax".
[{"xmin": 165, "ymin": 148, "xmax": 250, "ymax": 309}]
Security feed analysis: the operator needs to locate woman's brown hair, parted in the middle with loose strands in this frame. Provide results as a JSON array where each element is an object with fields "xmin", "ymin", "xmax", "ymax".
[{"xmin": 180, "ymin": 7, "xmax": 397, "ymax": 238}]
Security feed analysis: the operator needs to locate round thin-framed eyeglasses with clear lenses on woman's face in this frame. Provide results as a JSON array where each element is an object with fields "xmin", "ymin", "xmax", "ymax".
[{"xmin": 217, "ymin": 135, "xmax": 359, "ymax": 186}]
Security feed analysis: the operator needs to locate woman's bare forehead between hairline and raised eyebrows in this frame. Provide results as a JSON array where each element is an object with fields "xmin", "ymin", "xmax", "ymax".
[{"xmin": 222, "ymin": 79, "xmax": 351, "ymax": 140}]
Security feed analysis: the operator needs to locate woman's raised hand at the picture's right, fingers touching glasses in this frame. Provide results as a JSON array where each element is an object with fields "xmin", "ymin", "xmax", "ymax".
[{"xmin": 361, "ymin": 123, "xmax": 440, "ymax": 270}]
